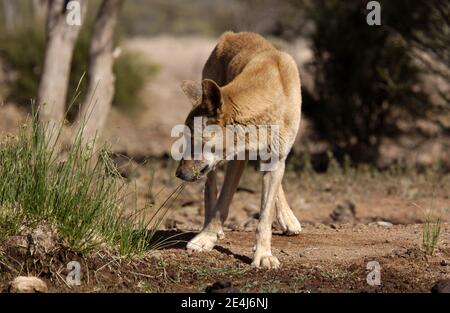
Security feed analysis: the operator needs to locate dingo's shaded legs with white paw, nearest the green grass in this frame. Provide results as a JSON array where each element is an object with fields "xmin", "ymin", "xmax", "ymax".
[{"xmin": 187, "ymin": 161, "xmax": 246, "ymax": 251}]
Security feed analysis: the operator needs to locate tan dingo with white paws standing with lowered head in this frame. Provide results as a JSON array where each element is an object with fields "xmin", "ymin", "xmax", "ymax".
[{"xmin": 176, "ymin": 32, "xmax": 301, "ymax": 268}]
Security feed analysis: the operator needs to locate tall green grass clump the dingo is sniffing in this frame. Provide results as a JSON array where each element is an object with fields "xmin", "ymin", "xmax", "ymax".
[{"xmin": 0, "ymin": 111, "xmax": 183, "ymax": 256}]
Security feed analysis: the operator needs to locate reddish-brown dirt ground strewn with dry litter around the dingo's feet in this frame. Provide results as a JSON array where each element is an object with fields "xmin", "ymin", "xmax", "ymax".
[{"xmin": 0, "ymin": 162, "xmax": 450, "ymax": 292}]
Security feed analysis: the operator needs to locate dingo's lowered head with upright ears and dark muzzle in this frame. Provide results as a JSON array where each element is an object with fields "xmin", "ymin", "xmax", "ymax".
[{"xmin": 176, "ymin": 79, "xmax": 225, "ymax": 182}]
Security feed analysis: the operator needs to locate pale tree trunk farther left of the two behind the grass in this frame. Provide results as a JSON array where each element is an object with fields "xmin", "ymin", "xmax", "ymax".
[{"xmin": 38, "ymin": 0, "xmax": 84, "ymax": 145}]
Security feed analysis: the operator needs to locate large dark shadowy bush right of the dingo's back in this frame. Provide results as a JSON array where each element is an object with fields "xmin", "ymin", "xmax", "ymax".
[{"xmin": 304, "ymin": 0, "xmax": 429, "ymax": 163}]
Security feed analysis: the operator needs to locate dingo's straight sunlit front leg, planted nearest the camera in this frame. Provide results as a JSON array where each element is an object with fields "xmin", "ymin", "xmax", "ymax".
[{"xmin": 252, "ymin": 160, "xmax": 285, "ymax": 269}]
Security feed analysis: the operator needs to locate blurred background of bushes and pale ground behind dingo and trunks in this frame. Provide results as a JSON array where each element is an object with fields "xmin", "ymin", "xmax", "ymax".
[{"xmin": 0, "ymin": 0, "xmax": 450, "ymax": 171}]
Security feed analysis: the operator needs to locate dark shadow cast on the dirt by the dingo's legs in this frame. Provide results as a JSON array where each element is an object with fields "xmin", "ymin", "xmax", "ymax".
[{"xmin": 149, "ymin": 229, "xmax": 252, "ymax": 264}]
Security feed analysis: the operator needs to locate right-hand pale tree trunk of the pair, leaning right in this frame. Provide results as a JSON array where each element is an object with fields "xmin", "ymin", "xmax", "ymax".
[{"xmin": 76, "ymin": 0, "xmax": 123, "ymax": 144}]
